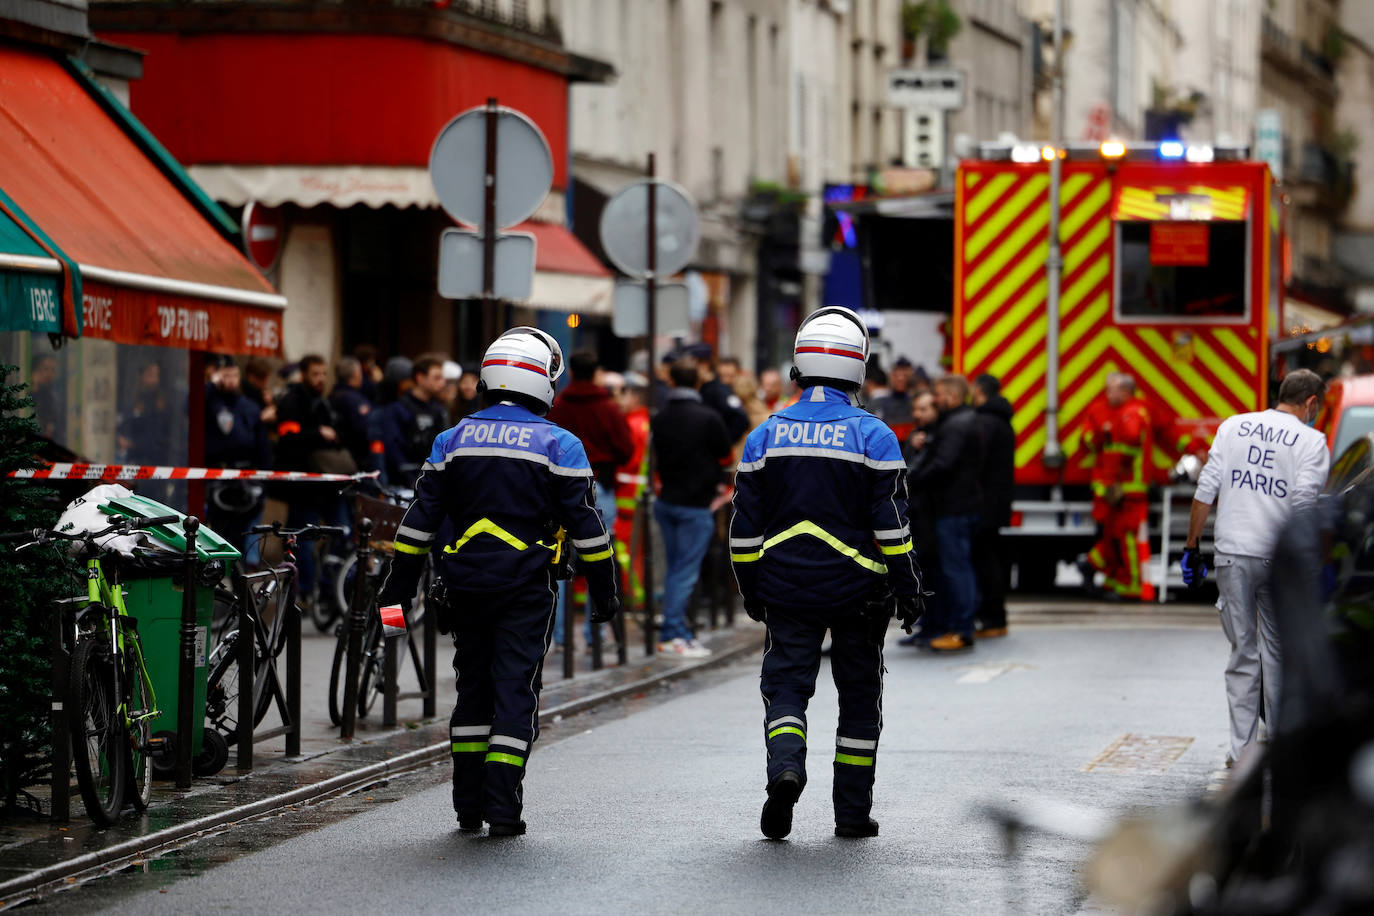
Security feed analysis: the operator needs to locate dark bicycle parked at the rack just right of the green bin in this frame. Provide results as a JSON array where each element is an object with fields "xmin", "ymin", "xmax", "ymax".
[{"xmin": 205, "ymin": 523, "xmax": 348, "ymax": 737}]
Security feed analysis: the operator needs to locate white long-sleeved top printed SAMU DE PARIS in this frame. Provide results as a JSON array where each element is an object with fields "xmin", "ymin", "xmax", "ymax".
[{"xmin": 1194, "ymin": 411, "xmax": 1331, "ymax": 559}]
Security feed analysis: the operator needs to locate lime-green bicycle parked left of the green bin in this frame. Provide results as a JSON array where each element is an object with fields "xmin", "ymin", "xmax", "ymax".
[{"xmin": 0, "ymin": 515, "xmax": 181, "ymax": 827}]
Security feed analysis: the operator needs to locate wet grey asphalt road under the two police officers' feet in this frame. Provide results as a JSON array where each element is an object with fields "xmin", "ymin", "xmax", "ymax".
[{"xmin": 48, "ymin": 626, "xmax": 1226, "ymax": 913}]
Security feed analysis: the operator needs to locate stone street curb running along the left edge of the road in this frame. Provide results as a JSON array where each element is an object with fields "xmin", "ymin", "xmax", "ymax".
[{"xmin": 0, "ymin": 633, "xmax": 763, "ymax": 909}]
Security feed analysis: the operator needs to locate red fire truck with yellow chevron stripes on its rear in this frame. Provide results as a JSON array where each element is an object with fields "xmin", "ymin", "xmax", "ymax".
[{"xmin": 951, "ymin": 141, "xmax": 1283, "ymax": 586}]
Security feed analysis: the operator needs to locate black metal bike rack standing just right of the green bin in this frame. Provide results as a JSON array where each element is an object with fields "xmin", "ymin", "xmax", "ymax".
[{"xmin": 234, "ymin": 569, "xmax": 301, "ymax": 772}]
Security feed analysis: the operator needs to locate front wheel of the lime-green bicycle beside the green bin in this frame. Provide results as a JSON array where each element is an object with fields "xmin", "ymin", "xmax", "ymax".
[{"xmin": 67, "ymin": 637, "xmax": 129, "ymax": 827}]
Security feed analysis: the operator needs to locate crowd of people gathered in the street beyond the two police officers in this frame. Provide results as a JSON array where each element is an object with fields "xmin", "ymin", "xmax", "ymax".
[{"xmin": 206, "ymin": 336, "xmax": 1013, "ymax": 658}]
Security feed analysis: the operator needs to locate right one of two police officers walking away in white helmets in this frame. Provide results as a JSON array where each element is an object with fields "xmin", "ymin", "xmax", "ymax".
[{"xmin": 730, "ymin": 306, "xmax": 923, "ymax": 839}]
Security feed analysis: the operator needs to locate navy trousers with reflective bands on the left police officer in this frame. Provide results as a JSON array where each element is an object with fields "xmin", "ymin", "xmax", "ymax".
[{"xmin": 449, "ymin": 573, "xmax": 558, "ymax": 821}]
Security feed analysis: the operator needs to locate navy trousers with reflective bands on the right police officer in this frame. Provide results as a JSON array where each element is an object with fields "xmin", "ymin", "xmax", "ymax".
[{"xmin": 760, "ymin": 607, "xmax": 888, "ymax": 824}]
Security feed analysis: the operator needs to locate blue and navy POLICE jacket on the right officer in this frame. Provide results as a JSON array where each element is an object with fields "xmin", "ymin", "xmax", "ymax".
[{"xmin": 730, "ymin": 386, "xmax": 921, "ymax": 608}]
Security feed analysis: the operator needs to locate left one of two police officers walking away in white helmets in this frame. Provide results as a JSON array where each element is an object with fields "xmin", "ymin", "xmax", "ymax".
[{"xmin": 378, "ymin": 327, "xmax": 620, "ymax": 836}]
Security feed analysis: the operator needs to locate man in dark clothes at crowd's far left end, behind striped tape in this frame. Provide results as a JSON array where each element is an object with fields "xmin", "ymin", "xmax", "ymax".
[{"xmin": 205, "ymin": 356, "xmax": 272, "ymax": 566}]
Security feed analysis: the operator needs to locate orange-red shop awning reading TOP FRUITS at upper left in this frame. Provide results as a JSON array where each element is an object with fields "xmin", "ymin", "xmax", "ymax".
[{"xmin": 0, "ymin": 47, "xmax": 286, "ymax": 354}]
